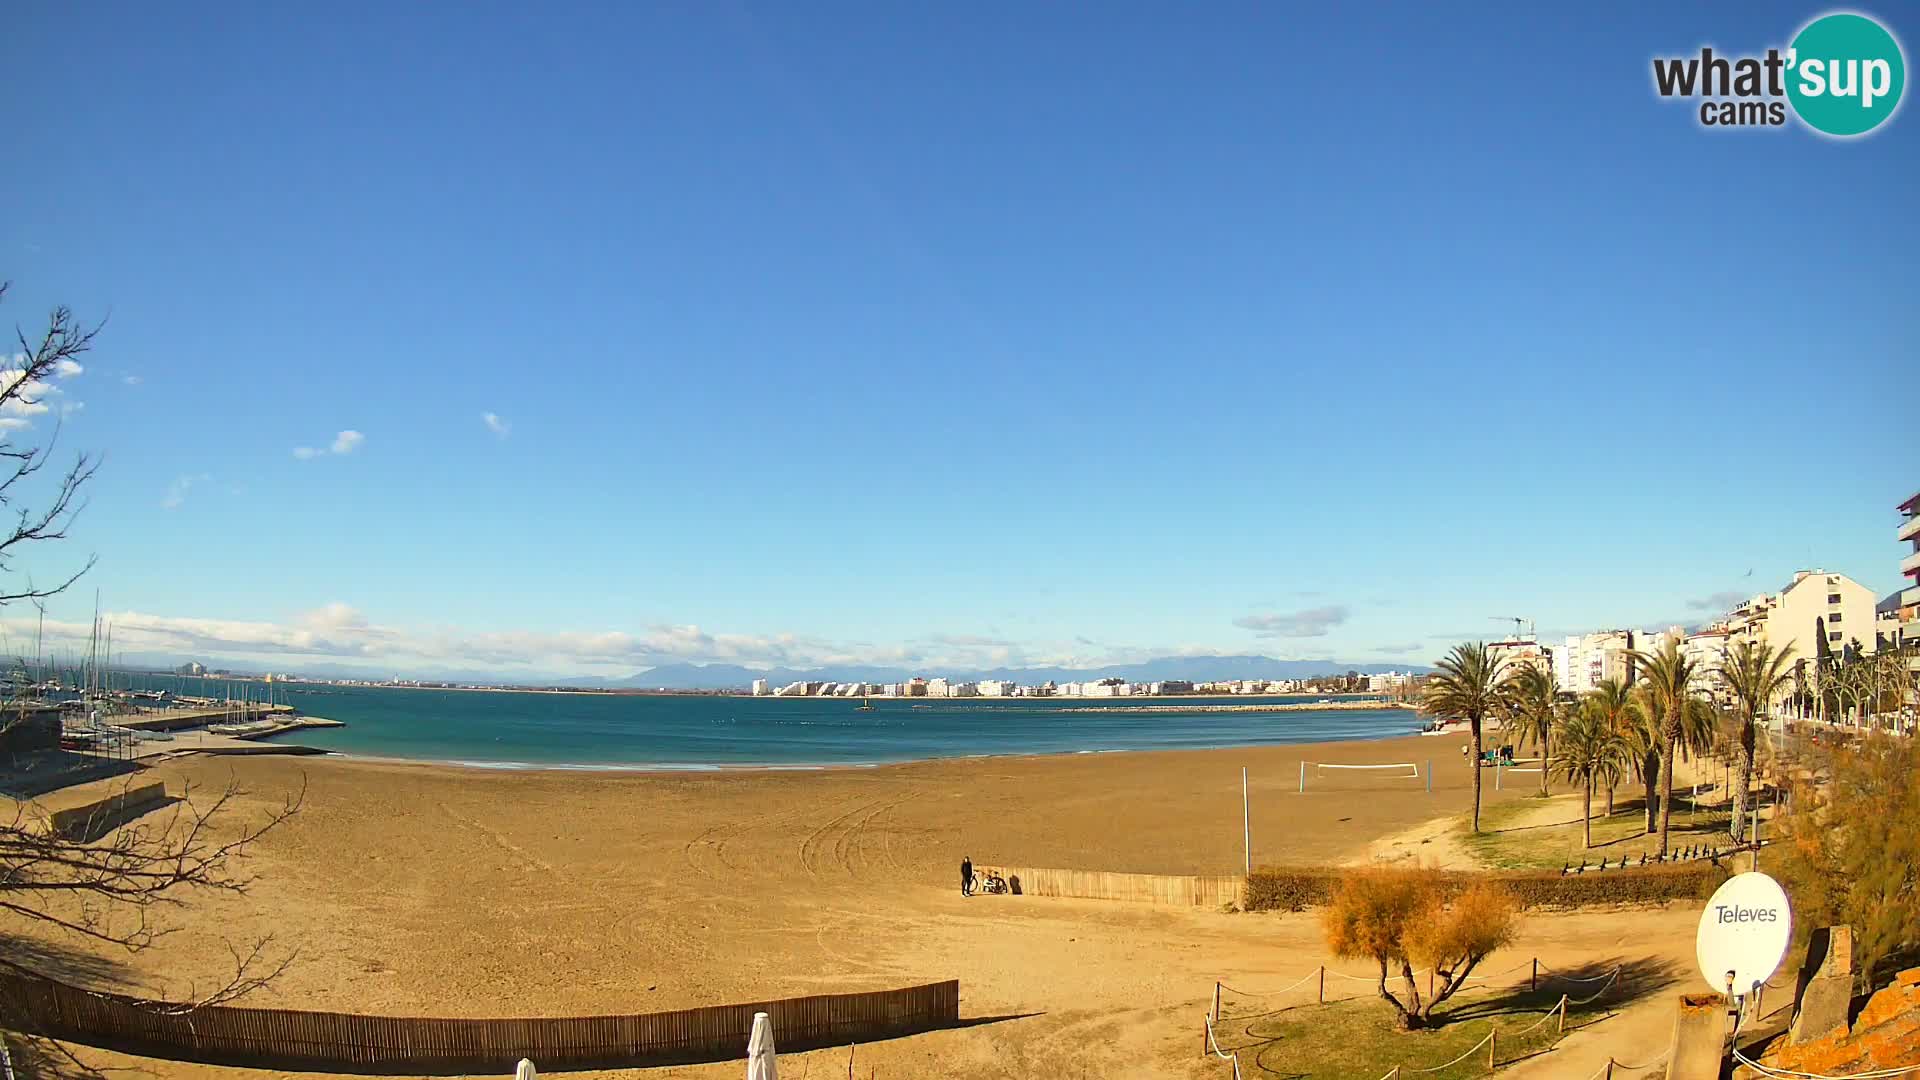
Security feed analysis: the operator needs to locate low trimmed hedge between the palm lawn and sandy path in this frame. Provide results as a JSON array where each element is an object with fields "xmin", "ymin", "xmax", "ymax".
[{"xmin": 1246, "ymin": 859, "xmax": 1728, "ymax": 911}]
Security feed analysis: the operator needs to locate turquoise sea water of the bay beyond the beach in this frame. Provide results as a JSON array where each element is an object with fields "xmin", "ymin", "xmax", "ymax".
[{"xmin": 183, "ymin": 684, "xmax": 1419, "ymax": 769}]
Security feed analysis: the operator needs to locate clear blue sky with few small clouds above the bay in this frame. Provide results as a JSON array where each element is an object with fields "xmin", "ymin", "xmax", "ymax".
[{"xmin": 0, "ymin": 4, "xmax": 1920, "ymax": 673}]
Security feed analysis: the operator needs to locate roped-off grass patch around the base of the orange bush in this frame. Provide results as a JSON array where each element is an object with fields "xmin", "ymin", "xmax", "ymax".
[{"xmin": 1213, "ymin": 980, "xmax": 1607, "ymax": 1080}]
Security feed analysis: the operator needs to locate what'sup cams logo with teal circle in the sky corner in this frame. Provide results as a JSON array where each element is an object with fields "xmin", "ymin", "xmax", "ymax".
[{"xmin": 1653, "ymin": 12, "xmax": 1907, "ymax": 138}]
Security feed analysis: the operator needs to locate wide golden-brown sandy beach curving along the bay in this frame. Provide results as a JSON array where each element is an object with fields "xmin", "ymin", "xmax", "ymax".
[{"xmin": 0, "ymin": 738, "xmax": 1695, "ymax": 1078}]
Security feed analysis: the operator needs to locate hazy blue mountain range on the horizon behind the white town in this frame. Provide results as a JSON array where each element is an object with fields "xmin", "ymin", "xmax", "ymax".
[{"xmin": 610, "ymin": 655, "xmax": 1432, "ymax": 690}]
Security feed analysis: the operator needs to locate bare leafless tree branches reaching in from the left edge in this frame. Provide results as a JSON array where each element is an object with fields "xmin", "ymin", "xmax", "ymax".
[{"xmin": 0, "ymin": 282, "xmax": 305, "ymax": 1028}]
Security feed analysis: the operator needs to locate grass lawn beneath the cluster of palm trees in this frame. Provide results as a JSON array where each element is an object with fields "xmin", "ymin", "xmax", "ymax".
[{"xmin": 1459, "ymin": 792, "xmax": 1732, "ymax": 871}]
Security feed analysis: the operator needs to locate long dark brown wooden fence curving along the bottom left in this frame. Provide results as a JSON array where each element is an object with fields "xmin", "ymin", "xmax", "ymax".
[{"xmin": 0, "ymin": 969, "xmax": 960, "ymax": 1076}]
